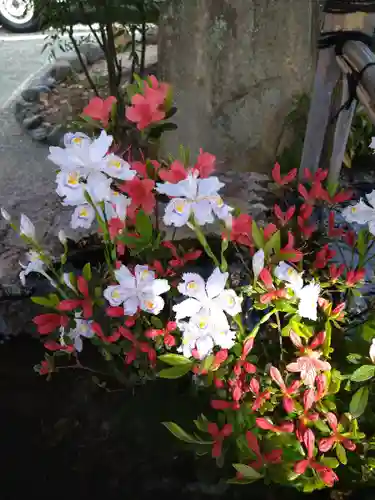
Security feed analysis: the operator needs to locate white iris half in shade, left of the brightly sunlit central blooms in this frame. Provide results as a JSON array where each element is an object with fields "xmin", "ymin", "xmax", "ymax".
[{"xmin": 104, "ymin": 265, "xmax": 170, "ymax": 316}]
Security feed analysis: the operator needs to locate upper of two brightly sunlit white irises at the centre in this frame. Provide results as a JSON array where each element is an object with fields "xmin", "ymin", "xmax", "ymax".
[{"xmin": 173, "ymin": 268, "xmax": 241, "ymax": 330}]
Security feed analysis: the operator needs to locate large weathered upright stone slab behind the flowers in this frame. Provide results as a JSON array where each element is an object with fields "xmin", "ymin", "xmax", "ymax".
[{"xmin": 159, "ymin": 0, "xmax": 319, "ymax": 171}]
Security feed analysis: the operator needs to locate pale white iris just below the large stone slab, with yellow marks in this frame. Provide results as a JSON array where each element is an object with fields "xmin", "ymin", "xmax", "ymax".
[{"xmin": 156, "ymin": 173, "xmax": 231, "ymax": 227}]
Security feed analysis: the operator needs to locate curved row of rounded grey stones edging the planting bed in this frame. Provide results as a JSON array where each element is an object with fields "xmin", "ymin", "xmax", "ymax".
[{"xmin": 13, "ymin": 43, "xmax": 104, "ymax": 146}]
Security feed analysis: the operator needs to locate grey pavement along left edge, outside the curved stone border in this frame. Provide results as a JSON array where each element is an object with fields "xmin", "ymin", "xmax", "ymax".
[{"xmin": 0, "ymin": 30, "xmax": 86, "ymax": 284}]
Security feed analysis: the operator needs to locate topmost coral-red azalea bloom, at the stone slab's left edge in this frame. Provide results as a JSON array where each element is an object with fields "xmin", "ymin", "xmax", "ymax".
[{"xmin": 126, "ymin": 76, "xmax": 169, "ymax": 130}]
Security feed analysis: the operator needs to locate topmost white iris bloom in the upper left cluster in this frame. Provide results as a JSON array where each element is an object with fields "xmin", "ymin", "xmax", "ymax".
[{"xmin": 48, "ymin": 130, "xmax": 113, "ymax": 175}]
